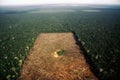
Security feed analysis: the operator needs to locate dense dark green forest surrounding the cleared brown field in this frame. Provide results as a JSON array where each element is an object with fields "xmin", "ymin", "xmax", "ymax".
[{"xmin": 0, "ymin": 7, "xmax": 120, "ymax": 80}]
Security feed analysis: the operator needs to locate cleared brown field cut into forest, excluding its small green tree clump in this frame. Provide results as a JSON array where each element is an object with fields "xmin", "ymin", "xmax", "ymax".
[{"xmin": 18, "ymin": 33, "xmax": 98, "ymax": 80}]
